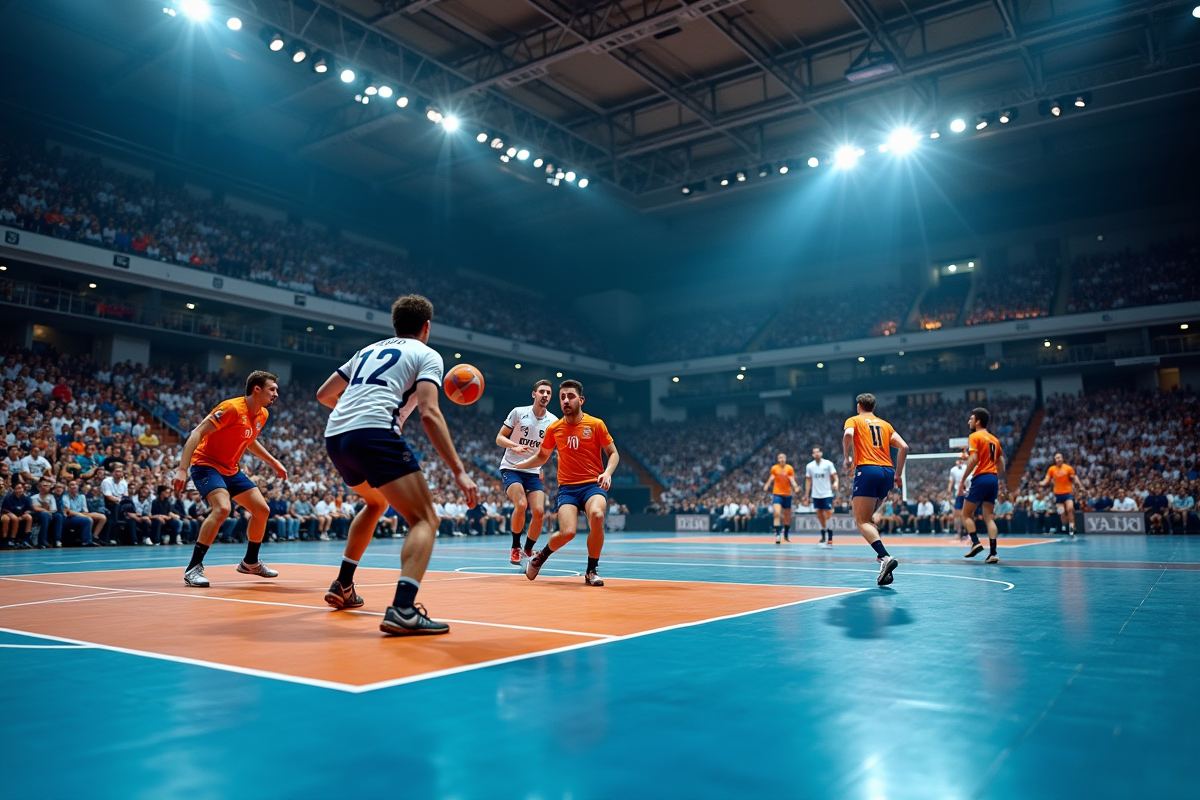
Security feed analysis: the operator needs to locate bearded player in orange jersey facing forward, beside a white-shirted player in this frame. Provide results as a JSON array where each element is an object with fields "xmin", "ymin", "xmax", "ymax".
[{"xmin": 514, "ymin": 380, "xmax": 620, "ymax": 587}]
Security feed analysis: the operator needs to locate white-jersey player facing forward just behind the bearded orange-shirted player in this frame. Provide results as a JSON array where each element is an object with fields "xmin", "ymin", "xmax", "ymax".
[{"xmin": 496, "ymin": 379, "xmax": 558, "ymax": 569}]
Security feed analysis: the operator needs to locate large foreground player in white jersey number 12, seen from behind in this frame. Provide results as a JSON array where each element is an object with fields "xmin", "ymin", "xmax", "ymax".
[{"xmin": 317, "ymin": 295, "xmax": 478, "ymax": 636}]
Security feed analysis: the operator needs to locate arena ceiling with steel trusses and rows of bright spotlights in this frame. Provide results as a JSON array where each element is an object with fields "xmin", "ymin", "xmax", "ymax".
[{"xmin": 7, "ymin": 0, "xmax": 1200, "ymax": 209}]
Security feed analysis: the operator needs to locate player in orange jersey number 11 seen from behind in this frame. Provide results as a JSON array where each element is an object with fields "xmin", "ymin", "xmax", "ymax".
[{"xmin": 841, "ymin": 392, "xmax": 908, "ymax": 587}]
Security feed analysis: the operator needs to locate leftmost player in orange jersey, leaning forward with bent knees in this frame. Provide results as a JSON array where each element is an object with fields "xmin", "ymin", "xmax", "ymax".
[{"xmin": 172, "ymin": 371, "xmax": 288, "ymax": 587}]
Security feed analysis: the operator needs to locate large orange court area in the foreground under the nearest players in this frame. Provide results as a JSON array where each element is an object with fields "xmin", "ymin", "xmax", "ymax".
[{"xmin": 0, "ymin": 564, "xmax": 857, "ymax": 692}]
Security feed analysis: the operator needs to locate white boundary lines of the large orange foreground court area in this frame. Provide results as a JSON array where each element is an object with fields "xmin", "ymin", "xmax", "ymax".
[{"xmin": 0, "ymin": 565, "xmax": 866, "ymax": 694}]
